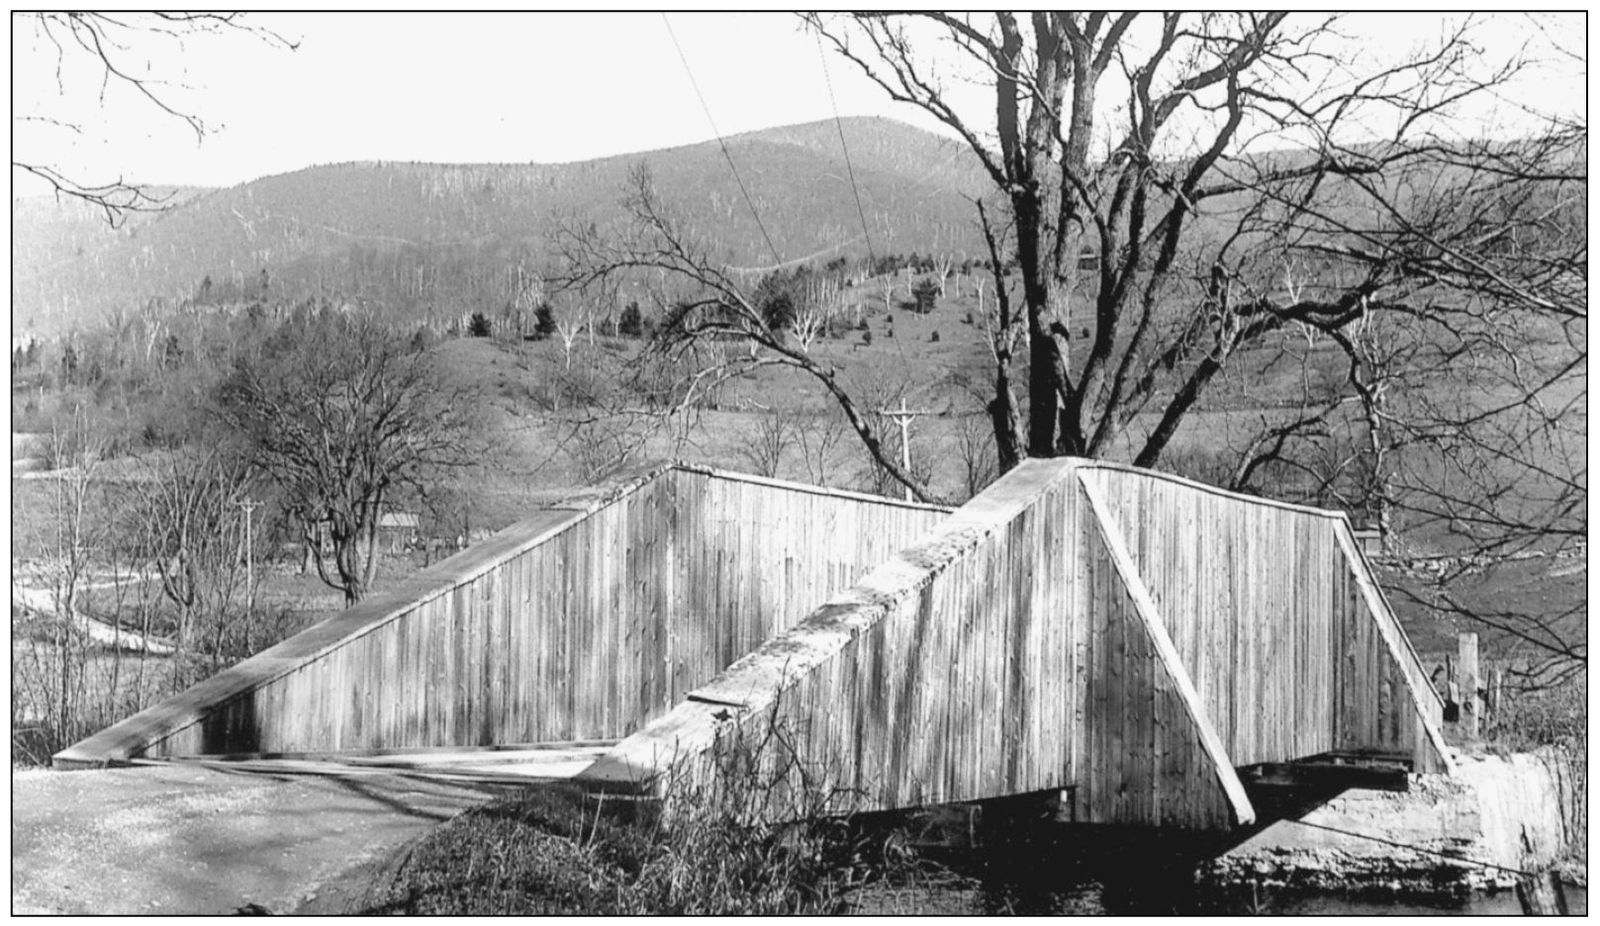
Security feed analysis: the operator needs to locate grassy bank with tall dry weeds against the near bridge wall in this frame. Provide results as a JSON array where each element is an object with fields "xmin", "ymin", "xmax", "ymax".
[{"xmin": 350, "ymin": 713, "xmax": 904, "ymax": 915}]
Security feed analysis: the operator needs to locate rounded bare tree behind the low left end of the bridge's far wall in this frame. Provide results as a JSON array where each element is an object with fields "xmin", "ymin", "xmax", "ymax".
[{"xmin": 219, "ymin": 313, "xmax": 490, "ymax": 605}]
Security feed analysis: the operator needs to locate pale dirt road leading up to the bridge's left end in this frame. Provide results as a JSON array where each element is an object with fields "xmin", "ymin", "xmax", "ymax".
[{"xmin": 11, "ymin": 766, "xmax": 504, "ymax": 913}]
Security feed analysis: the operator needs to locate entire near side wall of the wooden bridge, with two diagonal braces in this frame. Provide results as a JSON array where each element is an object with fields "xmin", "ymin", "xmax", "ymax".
[{"xmin": 579, "ymin": 459, "xmax": 1448, "ymax": 828}]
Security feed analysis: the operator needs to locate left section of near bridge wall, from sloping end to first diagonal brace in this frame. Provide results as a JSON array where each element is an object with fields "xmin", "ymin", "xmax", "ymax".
[{"xmin": 581, "ymin": 461, "xmax": 1253, "ymax": 827}]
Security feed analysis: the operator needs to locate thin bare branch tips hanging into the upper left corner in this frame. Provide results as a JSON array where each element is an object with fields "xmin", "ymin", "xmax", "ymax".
[{"xmin": 11, "ymin": 11, "xmax": 296, "ymax": 226}]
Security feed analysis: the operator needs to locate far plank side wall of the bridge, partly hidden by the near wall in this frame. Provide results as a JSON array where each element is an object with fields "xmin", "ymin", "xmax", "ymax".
[{"xmin": 56, "ymin": 465, "xmax": 947, "ymax": 768}]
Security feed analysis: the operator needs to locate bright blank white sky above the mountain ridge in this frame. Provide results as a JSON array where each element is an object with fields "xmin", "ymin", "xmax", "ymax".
[{"xmin": 13, "ymin": 13, "xmax": 1586, "ymax": 194}]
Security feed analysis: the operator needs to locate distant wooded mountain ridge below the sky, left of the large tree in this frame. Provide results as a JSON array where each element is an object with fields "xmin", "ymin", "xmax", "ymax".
[{"xmin": 11, "ymin": 117, "xmax": 986, "ymax": 334}]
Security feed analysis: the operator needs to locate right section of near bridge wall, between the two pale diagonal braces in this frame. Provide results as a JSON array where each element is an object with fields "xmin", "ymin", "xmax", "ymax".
[{"xmin": 1082, "ymin": 464, "xmax": 1445, "ymax": 771}]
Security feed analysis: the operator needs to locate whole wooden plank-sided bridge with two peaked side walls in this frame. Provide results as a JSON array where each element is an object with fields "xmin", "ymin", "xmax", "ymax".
[{"xmin": 56, "ymin": 459, "xmax": 1450, "ymax": 830}]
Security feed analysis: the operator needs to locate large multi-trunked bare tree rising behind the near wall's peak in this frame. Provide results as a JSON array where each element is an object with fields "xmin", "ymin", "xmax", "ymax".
[{"xmin": 808, "ymin": 13, "xmax": 1568, "ymax": 479}]
